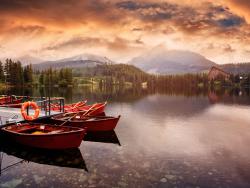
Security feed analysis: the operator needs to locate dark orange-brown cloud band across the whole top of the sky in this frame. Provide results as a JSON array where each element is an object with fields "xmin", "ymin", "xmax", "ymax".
[{"xmin": 0, "ymin": 0, "xmax": 245, "ymax": 36}]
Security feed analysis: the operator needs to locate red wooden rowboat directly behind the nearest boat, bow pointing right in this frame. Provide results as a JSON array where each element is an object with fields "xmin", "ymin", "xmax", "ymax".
[{"xmin": 51, "ymin": 113, "xmax": 120, "ymax": 132}]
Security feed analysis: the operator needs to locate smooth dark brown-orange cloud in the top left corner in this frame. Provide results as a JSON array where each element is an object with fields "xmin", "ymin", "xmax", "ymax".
[{"xmin": 0, "ymin": 0, "xmax": 122, "ymax": 27}]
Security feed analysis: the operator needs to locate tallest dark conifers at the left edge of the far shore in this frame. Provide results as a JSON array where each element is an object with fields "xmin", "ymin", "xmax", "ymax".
[{"xmin": 0, "ymin": 59, "xmax": 33, "ymax": 86}]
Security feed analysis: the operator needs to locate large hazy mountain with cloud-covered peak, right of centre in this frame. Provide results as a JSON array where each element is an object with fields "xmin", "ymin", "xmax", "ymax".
[{"xmin": 128, "ymin": 45, "xmax": 217, "ymax": 74}]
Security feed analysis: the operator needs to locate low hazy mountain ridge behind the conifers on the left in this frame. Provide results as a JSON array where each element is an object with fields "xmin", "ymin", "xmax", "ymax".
[{"xmin": 33, "ymin": 54, "xmax": 113, "ymax": 70}]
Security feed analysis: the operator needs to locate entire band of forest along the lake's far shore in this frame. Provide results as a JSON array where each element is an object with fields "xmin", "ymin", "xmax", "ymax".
[{"xmin": 4, "ymin": 59, "xmax": 250, "ymax": 91}]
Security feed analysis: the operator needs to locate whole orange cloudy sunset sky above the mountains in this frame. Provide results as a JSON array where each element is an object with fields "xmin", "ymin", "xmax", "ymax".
[{"xmin": 0, "ymin": 0, "xmax": 250, "ymax": 64}]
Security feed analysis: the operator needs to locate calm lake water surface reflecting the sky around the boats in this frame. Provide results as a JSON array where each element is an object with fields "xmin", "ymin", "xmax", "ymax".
[{"xmin": 0, "ymin": 88, "xmax": 250, "ymax": 188}]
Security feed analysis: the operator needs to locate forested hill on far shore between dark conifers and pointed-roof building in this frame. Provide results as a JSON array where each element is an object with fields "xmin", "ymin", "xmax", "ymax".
[{"xmin": 73, "ymin": 64, "xmax": 208, "ymax": 88}]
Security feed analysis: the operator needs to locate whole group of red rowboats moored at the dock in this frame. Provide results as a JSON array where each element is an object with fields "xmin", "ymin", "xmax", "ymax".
[{"xmin": 0, "ymin": 97, "xmax": 120, "ymax": 149}]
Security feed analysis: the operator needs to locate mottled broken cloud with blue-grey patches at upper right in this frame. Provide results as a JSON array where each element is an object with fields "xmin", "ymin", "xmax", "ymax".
[{"xmin": 116, "ymin": 1, "xmax": 245, "ymax": 34}]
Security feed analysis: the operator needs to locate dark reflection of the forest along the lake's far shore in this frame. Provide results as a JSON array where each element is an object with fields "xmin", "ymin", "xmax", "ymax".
[{"xmin": 0, "ymin": 86, "xmax": 250, "ymax": 106}]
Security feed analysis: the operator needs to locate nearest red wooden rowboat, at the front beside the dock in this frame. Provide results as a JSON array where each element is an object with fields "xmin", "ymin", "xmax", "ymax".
[{"xmin": 1, "ymin": 123, "xmax": 86, "ymax": 149}]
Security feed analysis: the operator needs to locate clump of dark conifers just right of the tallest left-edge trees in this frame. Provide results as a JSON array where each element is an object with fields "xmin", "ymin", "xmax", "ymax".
[{"xmin": 36, "ymin": 68, "xmax": 73, "ymax": 87}]
